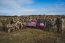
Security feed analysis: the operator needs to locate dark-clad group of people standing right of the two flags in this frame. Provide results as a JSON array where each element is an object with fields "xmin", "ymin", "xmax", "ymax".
[{"xmin": 44, "ymin": 16, "xmax": 62, "ymax": 32}]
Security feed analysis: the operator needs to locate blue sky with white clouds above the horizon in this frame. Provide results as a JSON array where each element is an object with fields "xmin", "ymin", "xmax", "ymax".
[{"xmin": 0, "ymin": 0, "xmax": 65, "ymax": 16}]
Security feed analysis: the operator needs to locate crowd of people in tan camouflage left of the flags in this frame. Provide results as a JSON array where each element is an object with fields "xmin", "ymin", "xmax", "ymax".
[{"xmin": 2, "ymin": 18, "xmax": 23, "ymax": 33}]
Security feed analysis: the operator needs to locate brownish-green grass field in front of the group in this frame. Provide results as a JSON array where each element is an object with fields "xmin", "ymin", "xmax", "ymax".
[{"xmin": 0, "ymin": 28, "xmax": 65, "ymax": 43}]
